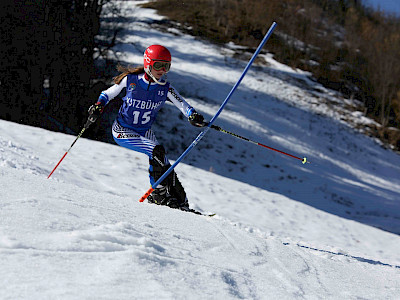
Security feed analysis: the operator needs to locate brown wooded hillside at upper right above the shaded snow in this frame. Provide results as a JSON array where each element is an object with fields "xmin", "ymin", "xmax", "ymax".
[{"xmin": 147, "ymin": 0, "xmax": 400, "ymax": 150}]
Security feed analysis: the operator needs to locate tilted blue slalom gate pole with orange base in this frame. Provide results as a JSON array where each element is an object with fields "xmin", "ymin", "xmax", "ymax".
[{"xmin": 139, "ymin": 22, "xmax": 276, "ymax": 202}]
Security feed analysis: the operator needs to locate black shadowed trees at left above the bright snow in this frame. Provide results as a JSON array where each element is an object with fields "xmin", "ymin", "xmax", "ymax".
[{"xmin": 0, "ymin": 0, "xmax": 117, "ymax": 141}]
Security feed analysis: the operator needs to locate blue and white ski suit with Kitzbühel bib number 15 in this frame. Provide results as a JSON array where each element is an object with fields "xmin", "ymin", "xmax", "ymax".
[{"xmin": 98, "ymin": 74, "xmax": 195, "ymax": 184}]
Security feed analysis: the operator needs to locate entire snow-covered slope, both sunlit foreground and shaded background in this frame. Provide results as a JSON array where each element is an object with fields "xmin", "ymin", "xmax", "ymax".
[{"xmin": 0, "ymin": 1, "xmax": 400, "ymax": 299}]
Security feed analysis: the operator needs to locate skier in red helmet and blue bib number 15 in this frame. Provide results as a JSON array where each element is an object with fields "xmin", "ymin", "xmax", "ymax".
[{"xmin": 89, "ymin": 45, "xmax": 205, "ymax": 210}]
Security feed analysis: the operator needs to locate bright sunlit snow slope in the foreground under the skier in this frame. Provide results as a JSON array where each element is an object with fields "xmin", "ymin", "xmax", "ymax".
[{"xmin": 0, "ymin": 121, "xmax": 400, "ymax": 299}]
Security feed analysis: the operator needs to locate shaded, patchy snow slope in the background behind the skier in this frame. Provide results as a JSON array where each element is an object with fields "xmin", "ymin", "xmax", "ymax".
[{"xmin": 104, "ymin": 1, "xmax": 400, "ymax": 233}]
